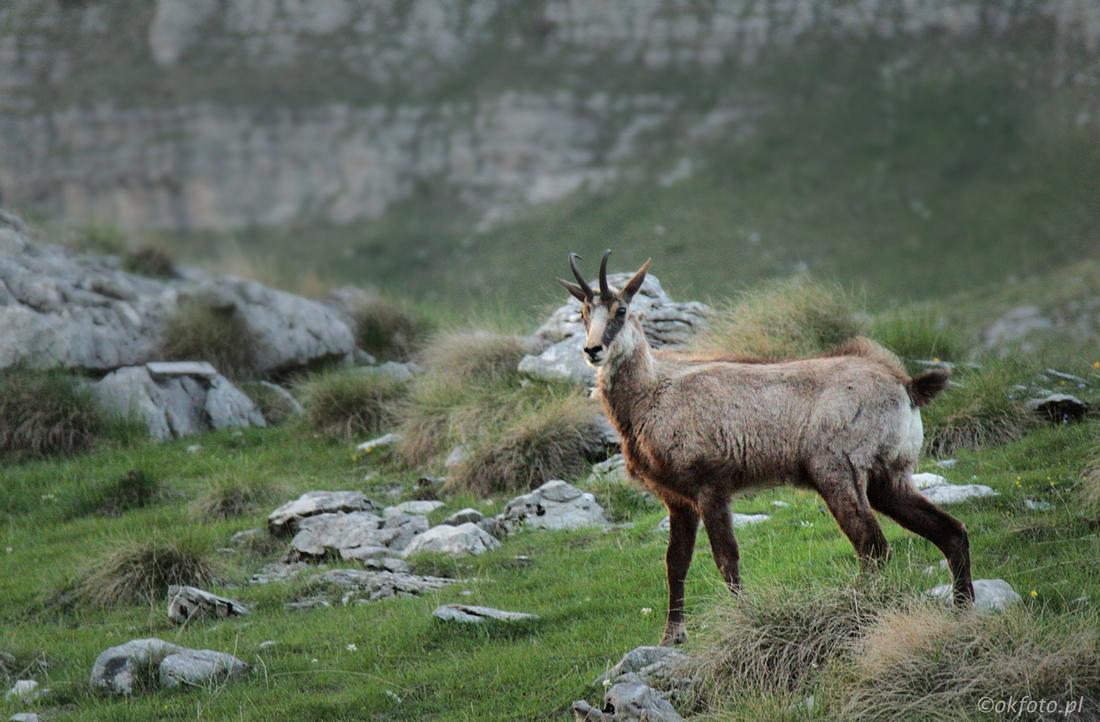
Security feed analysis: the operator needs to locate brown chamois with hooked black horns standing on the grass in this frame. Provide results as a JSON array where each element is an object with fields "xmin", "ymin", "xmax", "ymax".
[{"xmin": 558, "ymin": 250, "xmax": 974, "ymax": 645}]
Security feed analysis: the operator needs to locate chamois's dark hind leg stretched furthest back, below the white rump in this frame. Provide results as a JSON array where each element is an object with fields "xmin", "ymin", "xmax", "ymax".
[{"xmin": 867, "ymin": 467, "xmax": 974, "ymax": 606}]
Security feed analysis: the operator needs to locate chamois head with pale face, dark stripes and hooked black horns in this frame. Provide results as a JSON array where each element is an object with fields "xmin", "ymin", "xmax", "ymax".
[{"xmin": 558, "ymin": 249, "xmax": 649, "ymax": 367}]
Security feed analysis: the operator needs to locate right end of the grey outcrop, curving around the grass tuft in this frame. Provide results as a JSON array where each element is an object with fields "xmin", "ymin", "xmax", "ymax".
[{"xmin": 182, "ymin": 276, "xmax": 355, "ymax": 372}]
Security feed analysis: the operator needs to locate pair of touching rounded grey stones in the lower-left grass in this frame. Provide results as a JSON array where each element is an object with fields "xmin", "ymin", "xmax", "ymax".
[{"xmin": 90, "ymin": 638, "xmax": 249, "ymax": 696}]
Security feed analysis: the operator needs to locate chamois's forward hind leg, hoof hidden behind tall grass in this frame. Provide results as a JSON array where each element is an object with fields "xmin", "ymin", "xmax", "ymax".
[{"xmin": 810, "ymin": 457, "xmax": 890, "ymax": 571}]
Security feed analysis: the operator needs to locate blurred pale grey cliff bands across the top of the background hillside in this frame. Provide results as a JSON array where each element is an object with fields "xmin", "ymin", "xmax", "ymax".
[{"xmin": 0, "ymin": 0, "xmax": 1100, "ymax": 230}]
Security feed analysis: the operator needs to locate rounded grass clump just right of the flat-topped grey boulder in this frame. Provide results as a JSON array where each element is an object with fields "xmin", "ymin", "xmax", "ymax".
[{"xmin": 299, "ymin": 369, "xmax": 407, "ymax": 441}]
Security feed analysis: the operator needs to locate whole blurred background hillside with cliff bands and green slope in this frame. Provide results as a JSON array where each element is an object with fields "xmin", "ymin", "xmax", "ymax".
[{"xmin": 0, "ymin": 0, "xmax": 1100, "ymax": 314}]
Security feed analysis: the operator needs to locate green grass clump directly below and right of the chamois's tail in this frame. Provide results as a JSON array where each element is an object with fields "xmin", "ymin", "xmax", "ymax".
[{"xmin": 921, "ymin": 359, "xmax": 1037, "ymax": 456}]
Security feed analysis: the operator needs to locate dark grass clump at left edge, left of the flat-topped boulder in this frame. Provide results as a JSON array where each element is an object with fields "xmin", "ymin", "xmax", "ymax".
[{"xmin": 0, "ymin": 369, "xmax": 107, "ymax": 462}]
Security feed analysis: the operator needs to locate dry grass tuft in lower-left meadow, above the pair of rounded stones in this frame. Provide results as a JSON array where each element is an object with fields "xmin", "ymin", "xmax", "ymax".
[{"xmin": 76, "ymin": 539, "xmax": 218, "ymax": 606}]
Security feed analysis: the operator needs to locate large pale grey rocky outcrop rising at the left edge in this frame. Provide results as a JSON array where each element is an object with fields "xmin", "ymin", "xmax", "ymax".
[{"xmin": 0, "ymin": 214, "xmax": 355, "ymax": 374}]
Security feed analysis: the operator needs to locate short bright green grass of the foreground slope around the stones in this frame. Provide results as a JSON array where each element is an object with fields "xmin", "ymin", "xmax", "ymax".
[{"xmin": 0, "ymin": 424, "xmax": 1100, "ymax": 722}]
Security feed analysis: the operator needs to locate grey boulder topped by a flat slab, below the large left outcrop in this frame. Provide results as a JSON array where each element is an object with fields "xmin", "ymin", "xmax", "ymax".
[{"xmin": 91, "ymin": 367, "xmax": 266, "ymax": 440}]
